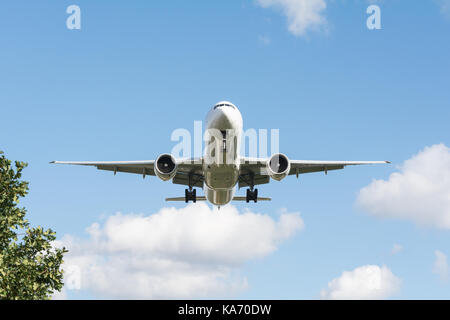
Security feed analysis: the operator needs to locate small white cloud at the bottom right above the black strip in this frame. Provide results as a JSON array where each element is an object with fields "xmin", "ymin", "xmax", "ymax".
[{"xmin": 320, "ymin": 265, "xmax": 401, "ymax": 300}]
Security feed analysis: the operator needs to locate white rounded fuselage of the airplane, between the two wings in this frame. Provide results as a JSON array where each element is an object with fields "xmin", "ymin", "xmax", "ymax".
[{"xmin": 203, "ymin": 101, "xmax": 242, "ymax": 205}]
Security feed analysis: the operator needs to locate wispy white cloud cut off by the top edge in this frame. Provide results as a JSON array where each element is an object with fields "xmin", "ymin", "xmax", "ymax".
[{"xmin": 257, "ymin": 0, "xmax": 327, "ymax": 36}]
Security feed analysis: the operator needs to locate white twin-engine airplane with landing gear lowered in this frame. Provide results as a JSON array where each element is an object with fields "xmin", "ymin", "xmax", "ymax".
[{"xmin": 50, "ymin": 101, "xmax": 390, "ymax": 208}]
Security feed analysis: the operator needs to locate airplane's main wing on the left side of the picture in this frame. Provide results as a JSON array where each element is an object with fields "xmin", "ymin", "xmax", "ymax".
[{"xmin": 50, "ymin": 159, "xmax": 203, "ymax": 187}]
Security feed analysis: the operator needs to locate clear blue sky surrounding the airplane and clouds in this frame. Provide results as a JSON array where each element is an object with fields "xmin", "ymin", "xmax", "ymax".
[{"xmin": 0, "ymin": 0, "xmax": 450, "ymax": 299}]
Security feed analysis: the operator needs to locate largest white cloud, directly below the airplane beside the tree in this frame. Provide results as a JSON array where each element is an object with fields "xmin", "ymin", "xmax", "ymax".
[{"xmin": 55, "ymin": 203, "xmax": 303, "ymax": 299}]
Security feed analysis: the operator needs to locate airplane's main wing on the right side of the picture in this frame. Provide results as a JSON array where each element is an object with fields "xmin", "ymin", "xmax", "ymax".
[{"xmin": 239, "ymin": 158, "xmax": 390, "ymax": 188}]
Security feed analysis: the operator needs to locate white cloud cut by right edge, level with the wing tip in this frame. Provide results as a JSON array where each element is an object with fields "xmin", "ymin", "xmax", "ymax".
[{"xmin": 357, "ymin": 144, "xmax": 450, "ymax": 229}]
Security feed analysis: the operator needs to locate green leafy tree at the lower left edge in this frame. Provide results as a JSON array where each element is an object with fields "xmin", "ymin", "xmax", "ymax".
[{"xmin": 0, "ymin": 151, "xmax": 68, "ymax": 300}]
